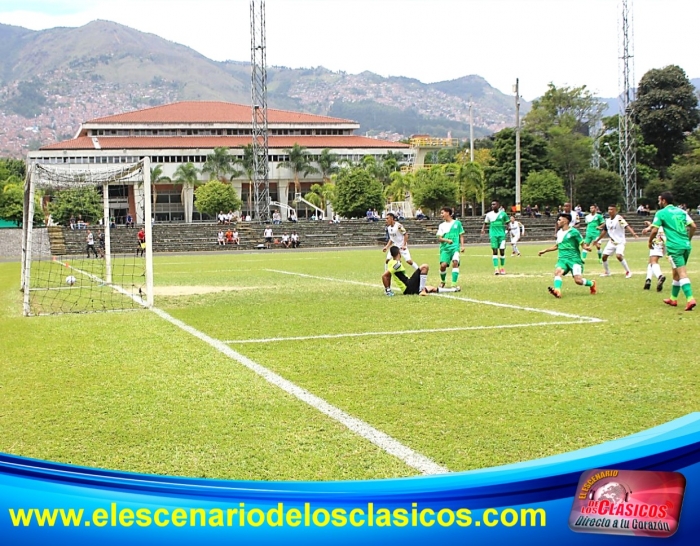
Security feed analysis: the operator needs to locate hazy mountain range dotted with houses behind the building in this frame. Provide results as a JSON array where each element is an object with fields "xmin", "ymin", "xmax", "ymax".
[{"xmin": 0, "ymin": 21, "xmax": 529, "ymax": 156}]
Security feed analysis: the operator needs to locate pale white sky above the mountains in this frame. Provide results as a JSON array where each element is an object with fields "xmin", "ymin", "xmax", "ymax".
[{"xmin": 0, "ymin": 0, "xmax": 700, "ymax": 100}]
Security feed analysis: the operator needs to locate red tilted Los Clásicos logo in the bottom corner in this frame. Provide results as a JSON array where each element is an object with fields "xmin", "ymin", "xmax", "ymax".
[{"xmin": 569, "ymin": 470, "xmax": 685, "ymax": 538}]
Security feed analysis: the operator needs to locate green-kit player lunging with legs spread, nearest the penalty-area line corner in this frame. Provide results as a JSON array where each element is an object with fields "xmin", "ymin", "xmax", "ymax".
[{"xmin": 537, "ymin": 213, "xmax": 597, "ymax": 298}]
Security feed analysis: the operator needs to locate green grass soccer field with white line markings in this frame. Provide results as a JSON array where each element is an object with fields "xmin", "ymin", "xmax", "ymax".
[{"xmin": 0, "ymin": 242, "xmax": 700, "ymax": 480}]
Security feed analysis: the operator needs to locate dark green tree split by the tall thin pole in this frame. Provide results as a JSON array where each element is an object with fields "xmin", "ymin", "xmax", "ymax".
[{"xmin": 485, "ymin": 129, "xmax": 550, "ymax": 205}]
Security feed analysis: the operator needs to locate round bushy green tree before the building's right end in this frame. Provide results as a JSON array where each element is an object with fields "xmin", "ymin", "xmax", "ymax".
[{"xmin": 332, "ymin": 167, "xmax": 384, "ymax": 218}]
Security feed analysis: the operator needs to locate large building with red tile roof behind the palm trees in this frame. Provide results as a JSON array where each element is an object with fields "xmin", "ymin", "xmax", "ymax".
[{"xmin": 28, "ymin": 101, "xmax": 413, "ymax": 222}]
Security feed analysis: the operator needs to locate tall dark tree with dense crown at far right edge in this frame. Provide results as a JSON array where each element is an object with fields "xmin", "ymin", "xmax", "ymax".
[{"xmin": 633, "ymin": 65, "xmax": 700, "ymax": 176}]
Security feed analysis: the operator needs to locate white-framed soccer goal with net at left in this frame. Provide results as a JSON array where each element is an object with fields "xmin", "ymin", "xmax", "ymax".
[{"xmin": 21, "ymin": 158, "xmax": 153, "ymax": 316}]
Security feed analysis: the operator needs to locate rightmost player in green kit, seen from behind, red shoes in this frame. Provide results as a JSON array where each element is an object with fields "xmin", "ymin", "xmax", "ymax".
[{"xmin": 649, "ymin": 191, "xmax": 697, "ymax": 311}]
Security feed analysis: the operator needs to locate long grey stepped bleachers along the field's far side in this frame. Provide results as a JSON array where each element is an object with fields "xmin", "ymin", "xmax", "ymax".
[{"xmin": 48, "ymin": 214, "xmax": 668, "ymax": 255}]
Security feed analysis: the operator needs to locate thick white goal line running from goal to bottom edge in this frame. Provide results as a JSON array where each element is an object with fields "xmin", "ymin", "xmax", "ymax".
[{"xmin": 47, "ymin": 262, "xmax": 450, "ymax": 475}]
